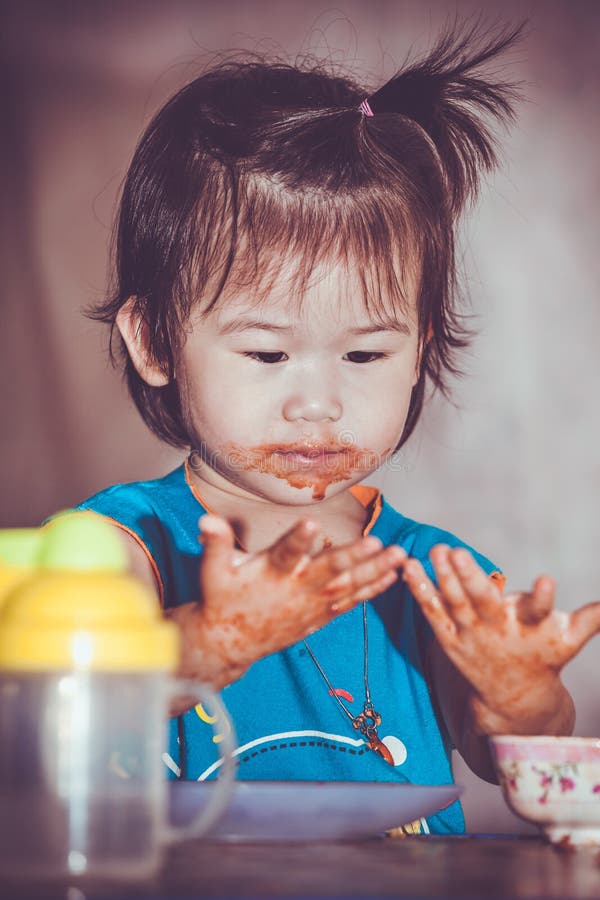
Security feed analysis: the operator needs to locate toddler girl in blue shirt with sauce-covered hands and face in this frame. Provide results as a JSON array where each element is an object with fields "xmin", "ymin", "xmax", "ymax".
[{"xmin": 76, "ymin": 24, "xmax": 600, "ymax": 832}]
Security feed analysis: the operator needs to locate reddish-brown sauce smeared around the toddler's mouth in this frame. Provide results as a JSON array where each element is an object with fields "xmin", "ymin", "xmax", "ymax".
[{"xmin": 223, "ymin": 439, "xmax": 389, "ymax": 500}]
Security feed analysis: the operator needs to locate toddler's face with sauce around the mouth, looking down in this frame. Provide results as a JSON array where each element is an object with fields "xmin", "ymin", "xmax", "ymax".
[{"xmin": 176, "ymin": 267, "xmax": 419, "ymax": 505}]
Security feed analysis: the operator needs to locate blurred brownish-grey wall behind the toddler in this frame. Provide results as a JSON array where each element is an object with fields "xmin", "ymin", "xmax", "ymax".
[{"xmin": 0, "ymin": 0, "xmax": 600, "ymax": 831}]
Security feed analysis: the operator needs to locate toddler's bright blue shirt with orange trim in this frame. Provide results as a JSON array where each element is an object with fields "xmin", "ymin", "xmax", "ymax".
[{"xmin": 79, "ymin": 465, "xmax": 496, "ymax": 834}]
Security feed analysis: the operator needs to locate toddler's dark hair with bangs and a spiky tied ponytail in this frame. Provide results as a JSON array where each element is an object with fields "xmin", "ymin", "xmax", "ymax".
[{"xmin": 91, "ymin": 26, "xmax": 522, "ymax": 446}]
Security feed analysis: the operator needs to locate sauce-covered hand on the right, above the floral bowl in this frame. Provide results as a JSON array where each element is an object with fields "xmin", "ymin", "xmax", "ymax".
[{"xmin": 403, "ymin": 544, "xmax": 600, "ymax": 733}]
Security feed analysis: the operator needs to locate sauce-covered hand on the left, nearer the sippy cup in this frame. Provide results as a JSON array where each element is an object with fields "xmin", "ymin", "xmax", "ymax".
[{"xmin": 167, "ymin": 515, "xmax": 406, "ymax": 696}]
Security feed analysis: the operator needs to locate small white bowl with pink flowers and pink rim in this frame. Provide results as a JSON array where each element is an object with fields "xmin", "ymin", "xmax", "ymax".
[{"xmin": 490, "ymin": 735, "xmax": 600, "ymax": 847}]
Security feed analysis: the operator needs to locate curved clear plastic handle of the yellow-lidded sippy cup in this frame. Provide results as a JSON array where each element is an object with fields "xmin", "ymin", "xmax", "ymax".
[{"xmin": 163, "ymin": 679, "xmax": 236, "ymax": 844}]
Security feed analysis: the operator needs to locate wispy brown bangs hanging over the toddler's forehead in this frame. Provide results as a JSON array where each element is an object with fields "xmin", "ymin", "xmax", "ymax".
[{"xmin": 188, "ymin": 174, "xmax": 426, "ymax": 322}]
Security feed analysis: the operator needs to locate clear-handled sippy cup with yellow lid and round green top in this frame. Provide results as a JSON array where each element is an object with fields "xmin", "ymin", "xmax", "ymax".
[{"xmin": 0, "ymin": 512, "xmax": 234, "ymax": 879}]
